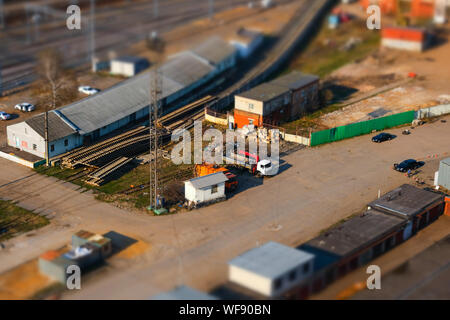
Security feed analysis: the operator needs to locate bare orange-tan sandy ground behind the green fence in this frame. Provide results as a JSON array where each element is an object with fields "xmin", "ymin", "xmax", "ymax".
[{"xmin": 320, "ymin": 4, "xmax": 450, "ymax": 127}]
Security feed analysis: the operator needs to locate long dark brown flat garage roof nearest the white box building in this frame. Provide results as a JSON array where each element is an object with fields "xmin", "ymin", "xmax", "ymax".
[{"xmin": 306, "ymin": 210, "xmax": 407, "ymax": 257}]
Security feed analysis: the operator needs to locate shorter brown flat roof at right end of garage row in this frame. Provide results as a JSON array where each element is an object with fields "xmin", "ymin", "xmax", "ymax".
[{"xmin": 369, "ymin": 184, "xmax": 444, "ymax": 217}]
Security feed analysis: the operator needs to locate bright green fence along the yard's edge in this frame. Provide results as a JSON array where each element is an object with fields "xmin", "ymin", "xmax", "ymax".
[{"xmin": 311, "ymin": 110, "xmax": 414, "ymax": 146}]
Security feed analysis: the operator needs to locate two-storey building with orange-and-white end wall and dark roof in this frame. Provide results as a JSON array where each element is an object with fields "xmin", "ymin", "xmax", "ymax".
[{"xmin": 234, "ymin": 71, "xmax": 319, "ymax": 128}]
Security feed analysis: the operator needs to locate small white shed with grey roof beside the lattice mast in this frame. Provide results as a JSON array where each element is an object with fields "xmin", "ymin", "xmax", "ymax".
[{"xmin": 184, "ymin": 172, "xmax": 228, "ymax": 203}]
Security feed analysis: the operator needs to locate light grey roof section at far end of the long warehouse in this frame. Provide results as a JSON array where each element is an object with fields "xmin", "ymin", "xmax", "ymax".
[{"xmin": 191, "ymin": 36, "xmax": 236, "ymax": 65}]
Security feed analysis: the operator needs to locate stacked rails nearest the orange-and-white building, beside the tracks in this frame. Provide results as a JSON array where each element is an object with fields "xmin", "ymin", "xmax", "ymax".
[{"xmin": 158, "ymin": 95, "xmax": 216, "ymax": 132}]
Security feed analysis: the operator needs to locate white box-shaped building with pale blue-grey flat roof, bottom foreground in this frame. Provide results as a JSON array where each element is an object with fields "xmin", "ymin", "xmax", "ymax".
[{"xmin": 228, "ymin": 241, "xmax": 314, "ymax": 298}]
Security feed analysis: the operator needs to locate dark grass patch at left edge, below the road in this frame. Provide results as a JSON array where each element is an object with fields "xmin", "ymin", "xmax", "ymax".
[{"xmin": 0, "ymin": 200, "xmax": 50, "ymax": 241}]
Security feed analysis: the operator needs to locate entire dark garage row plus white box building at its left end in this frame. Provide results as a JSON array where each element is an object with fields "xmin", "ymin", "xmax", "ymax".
[{"xmin": 222, "ymin": 184, "xmax": 444, "ymax": 299}]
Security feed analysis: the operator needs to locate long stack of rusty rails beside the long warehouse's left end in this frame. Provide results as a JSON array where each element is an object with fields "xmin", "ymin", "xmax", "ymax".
[{"xmin": 60, "ymin": 126, "xmax": 149, "ymax": 169}]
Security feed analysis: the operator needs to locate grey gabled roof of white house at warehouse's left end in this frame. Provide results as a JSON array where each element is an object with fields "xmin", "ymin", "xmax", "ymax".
[{"xmin": 25, "ymin": 110, "xmax": 77, "ymax": 141}]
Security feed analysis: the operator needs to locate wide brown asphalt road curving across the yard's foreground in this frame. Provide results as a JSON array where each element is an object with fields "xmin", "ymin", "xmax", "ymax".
[{"xmin": 0, "ymin": 117, "xmax": 450, "ymax": 299}]
